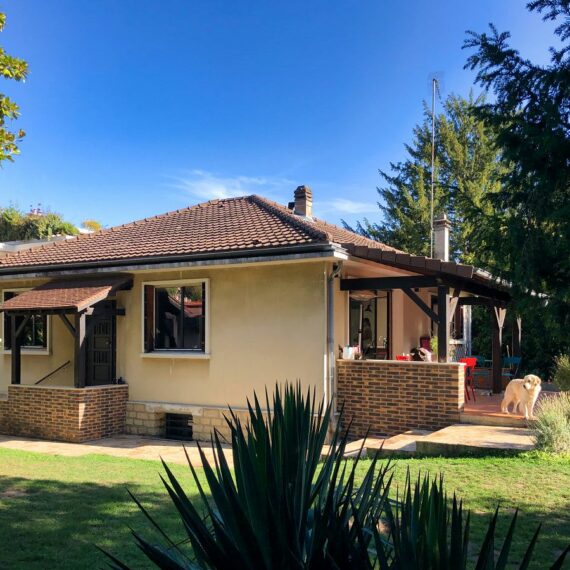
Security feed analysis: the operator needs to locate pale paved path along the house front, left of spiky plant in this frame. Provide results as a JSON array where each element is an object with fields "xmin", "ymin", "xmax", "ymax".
[{"xmin": 0, "ymin": 435, "xmax": 232, "ymax": 465}]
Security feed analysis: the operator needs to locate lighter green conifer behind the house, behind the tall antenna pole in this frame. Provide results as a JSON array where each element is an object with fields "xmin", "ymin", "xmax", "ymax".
[{"xmin": 350, "ymin": 94, "xmax": 504, "ymax": 265}]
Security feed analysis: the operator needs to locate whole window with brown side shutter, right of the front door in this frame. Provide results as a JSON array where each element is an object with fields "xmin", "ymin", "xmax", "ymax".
[{"xmin": 144, "ymin": 281, "xmax": 207, "ymax": 353}]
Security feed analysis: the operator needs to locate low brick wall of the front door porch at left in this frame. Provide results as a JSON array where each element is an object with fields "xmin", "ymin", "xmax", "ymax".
[{"xmin": 0, "ymin": 384, "xmax": 129, "ymax": 442}]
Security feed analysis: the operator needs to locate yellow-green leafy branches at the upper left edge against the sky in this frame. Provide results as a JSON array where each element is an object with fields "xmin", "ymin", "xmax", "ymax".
[{"xmin": 0, "ymin": 13, "xmax": 28, "ymax": 165}]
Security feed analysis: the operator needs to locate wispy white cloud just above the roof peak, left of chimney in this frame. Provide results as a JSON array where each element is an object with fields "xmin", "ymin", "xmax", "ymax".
[{"xmin": 169, "ymin": 169, "xmax": 293, "ymax": 200}]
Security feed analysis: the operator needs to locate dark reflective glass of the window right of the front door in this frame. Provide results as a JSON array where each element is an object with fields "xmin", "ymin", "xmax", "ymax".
[{"xmin": 154, "ymin": 284, "xmax": 206, "ymax": 351}]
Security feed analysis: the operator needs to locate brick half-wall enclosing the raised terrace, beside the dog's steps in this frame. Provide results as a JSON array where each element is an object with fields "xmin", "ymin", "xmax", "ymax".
[{"xmin": 337, "ymin": 360, "xmax": 465, "ymax": 437}]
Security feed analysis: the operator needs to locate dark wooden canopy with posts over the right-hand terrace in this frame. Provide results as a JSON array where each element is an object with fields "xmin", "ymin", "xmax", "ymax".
[{"xmin": 340, "ymin": 244, "xmax": 521, "ymax": 393}]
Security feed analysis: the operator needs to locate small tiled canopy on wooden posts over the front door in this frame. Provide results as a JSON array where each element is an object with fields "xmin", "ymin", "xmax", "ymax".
[{"xmin": 0, "ymin": 275, "xmax": 132, "ymax": 388}]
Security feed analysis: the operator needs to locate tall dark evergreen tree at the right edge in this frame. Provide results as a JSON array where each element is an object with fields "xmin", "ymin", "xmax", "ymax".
[{"xmin": 464, "ymin": 0, "xmax": 570, "ymax": 302}]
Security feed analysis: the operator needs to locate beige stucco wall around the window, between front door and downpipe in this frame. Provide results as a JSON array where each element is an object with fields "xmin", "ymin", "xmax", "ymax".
[{"xmin": 117, "ymin": 261, "xmax": 326, "ymax": 407}]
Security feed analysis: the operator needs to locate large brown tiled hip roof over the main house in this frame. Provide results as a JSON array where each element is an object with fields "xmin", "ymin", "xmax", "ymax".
[{"xmin": 0, "ymin": 196, "xmax": 396, "ymax": 271}]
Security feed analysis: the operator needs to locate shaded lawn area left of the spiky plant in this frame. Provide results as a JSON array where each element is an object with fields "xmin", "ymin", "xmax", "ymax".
[{"xmin": 0, "ymin": 476, "xmax": 196, "ymax": 570}]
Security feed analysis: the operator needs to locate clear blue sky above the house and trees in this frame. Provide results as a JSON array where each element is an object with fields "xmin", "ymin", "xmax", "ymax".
[{"xmin": 0, "ymin": 0, "xmax": 553, "ymax": 226}]
